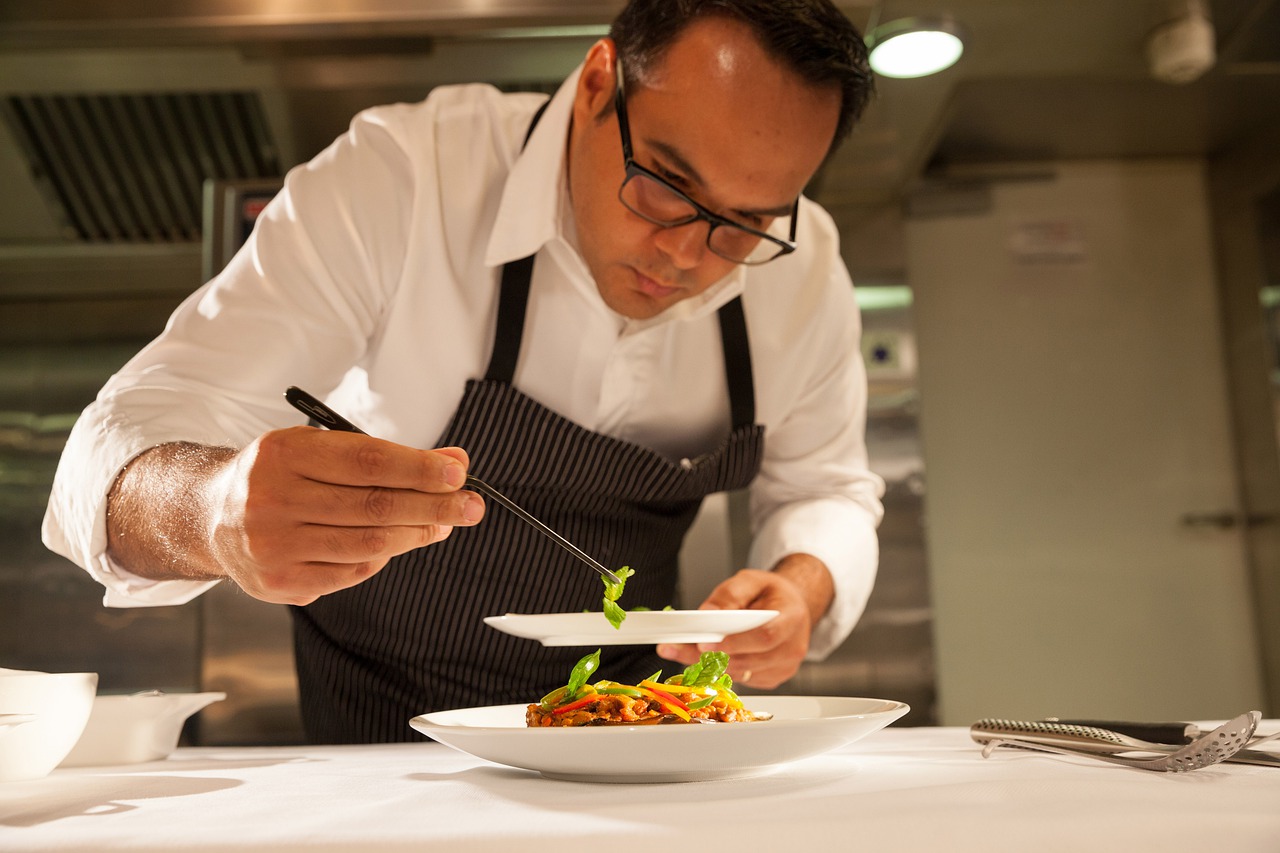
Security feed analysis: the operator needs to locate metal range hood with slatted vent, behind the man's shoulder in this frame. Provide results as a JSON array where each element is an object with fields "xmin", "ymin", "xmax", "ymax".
[{"xmin": 0, "ymin": 0, "xmax": 620, "ymax": 256}]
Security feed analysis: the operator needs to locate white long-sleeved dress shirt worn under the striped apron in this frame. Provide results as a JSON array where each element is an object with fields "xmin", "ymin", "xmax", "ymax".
[{"xmin": 44, "ymin": 64, "xmax": 883, "ymax": 658}]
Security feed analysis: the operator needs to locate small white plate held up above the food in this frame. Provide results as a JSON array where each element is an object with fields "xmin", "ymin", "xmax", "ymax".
[{"xmin": 484, "ymin": 610, "xmax": 778, "ymax": 646}]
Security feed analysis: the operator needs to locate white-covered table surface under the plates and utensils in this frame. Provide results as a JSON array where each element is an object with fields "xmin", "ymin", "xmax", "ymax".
[{"xmin": 0, "ymin": 721, "xmax": 1280, "ymax": 853}]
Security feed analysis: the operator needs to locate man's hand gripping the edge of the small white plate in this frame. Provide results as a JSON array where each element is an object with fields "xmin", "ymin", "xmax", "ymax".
[{"xmin": 658, "ymin": 555, "xmax": 835, "ymax": 689}]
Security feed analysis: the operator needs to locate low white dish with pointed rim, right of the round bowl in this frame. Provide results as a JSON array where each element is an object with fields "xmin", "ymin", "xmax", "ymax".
[{"xmin": 61, "ymin": 690, "xmax": 227, "ymax": 767}]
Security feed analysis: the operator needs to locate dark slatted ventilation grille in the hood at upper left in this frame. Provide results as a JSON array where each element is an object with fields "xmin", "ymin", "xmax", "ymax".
[{"xmin": 0, "ymin": 92, "xmax": 280, "ymax": 243}]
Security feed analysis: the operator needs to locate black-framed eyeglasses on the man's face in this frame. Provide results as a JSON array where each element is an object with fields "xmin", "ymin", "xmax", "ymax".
[{"xmin": 613, "ymin": 58, "xmax": 800, "ymax": 265}]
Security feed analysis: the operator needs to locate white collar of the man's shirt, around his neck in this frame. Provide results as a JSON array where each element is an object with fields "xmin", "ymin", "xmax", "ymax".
[{"xmin": 485, "ymin": 65, "xmax": 746, "ymax": 326}]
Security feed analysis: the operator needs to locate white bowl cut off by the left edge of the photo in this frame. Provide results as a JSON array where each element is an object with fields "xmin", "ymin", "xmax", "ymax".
[{"xmin": 0, "ymin": 669, "xmax": 97, "ymax": 783}]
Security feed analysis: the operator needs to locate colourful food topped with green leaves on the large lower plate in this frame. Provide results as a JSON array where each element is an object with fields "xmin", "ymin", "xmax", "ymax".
[{"xmin": 525, "ymin": 649, "xmax": 768, "ymax": 729}]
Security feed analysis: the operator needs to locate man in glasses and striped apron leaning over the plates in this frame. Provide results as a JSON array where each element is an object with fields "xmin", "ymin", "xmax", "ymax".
[{"xmin": 45, "ymin": 0, "xmax": 882, "ymax": 742}]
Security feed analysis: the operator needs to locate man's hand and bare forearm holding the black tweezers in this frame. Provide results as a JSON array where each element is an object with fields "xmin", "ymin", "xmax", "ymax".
[{"xmin": 108, "ymin": 427, "xmax": 484, "ymax": 605}]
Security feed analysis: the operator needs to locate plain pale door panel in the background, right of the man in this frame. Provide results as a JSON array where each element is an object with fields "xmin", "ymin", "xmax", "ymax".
[{"xmin": 906, "ymin": 160, "xmax": 1261, "ymax": 725}]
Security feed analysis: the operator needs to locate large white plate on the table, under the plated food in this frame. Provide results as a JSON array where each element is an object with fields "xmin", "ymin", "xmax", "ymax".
[{"xmin": 410, "ymin": 695, "xmax": 910, "ymax": 783}]
